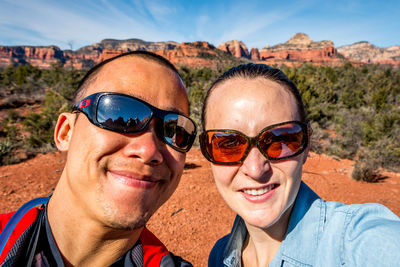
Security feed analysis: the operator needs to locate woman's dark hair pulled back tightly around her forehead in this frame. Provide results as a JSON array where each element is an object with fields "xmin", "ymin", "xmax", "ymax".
[{"xmin": 201, "ymin": 63, "xmax": 307, "ymax": 129}]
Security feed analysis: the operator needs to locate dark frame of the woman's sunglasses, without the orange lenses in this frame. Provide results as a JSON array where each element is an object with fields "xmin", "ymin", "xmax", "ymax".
[{"xmin": 199, "ymin": 120, "xmax": 310, "ymax": 165}]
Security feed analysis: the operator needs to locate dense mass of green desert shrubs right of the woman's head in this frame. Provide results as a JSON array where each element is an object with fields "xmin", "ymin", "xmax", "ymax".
[{"xmin": 283, "ymin": 62, "xmax": 400, "ymax": 180}]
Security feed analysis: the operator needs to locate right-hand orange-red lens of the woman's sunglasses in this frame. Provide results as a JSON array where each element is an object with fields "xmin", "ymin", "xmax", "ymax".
[{"xmin": 259, "ymin": 123, "xmax": 304, "ymax": 159}]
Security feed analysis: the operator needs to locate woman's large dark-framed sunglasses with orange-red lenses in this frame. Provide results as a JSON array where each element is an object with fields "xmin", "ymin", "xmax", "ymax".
[{"xmin": 200, "ymin": 121, "xmax": 308, "ymax": 165}]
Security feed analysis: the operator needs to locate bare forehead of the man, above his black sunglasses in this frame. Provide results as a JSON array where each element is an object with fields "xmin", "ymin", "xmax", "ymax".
[{"xmin": 86, "ymin": 56, "xmax": 188, "ymax": 114}]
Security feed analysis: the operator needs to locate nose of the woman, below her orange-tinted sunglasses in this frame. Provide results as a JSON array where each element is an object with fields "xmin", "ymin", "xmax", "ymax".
[{"xmin": 242, "ymin": 147, "xmax": 271, "ymax": 182}]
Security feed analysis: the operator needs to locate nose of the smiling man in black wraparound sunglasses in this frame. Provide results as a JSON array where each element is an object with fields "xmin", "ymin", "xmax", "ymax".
[{"xmin": 123, "ymin": 120, "xmax": 166, "ymax": 165}]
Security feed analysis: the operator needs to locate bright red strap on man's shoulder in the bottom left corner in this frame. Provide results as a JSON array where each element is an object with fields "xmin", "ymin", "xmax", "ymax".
[{"xmin": 0, "ymin": 208, "xmax": 38, "ymax": 263}]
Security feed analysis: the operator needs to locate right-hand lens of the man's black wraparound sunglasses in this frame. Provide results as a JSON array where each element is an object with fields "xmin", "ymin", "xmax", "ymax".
[{"xmin": 164, "ymin": 114, "xmax": 196, "ymax": 150}]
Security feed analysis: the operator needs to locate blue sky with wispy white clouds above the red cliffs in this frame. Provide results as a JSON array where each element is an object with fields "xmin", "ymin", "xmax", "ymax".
[{"xmin": 0, "ymin": 0, "xmax": 400, "ymax": 50}]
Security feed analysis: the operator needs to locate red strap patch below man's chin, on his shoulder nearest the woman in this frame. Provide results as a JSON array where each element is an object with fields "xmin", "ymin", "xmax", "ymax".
[{"xmin": 140, "ymin": 227, "xmax": 169, "ymax": 267}]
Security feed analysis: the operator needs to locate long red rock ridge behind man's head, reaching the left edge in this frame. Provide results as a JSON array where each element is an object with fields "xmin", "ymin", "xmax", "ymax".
[{"xmin": 0, "ymin": 39, "xmax": 242, "ymax": 69}]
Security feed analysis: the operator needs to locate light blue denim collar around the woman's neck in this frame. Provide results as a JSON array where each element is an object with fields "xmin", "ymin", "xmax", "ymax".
[{"xmin": 224, "ymin": 182, "xmax": 325, "ymax": 267}]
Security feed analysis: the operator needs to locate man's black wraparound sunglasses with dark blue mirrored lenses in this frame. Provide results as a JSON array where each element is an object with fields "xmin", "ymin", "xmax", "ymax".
[{"xmin": 72, "ymin": 93, "xmax": 196, "ymax": 152}]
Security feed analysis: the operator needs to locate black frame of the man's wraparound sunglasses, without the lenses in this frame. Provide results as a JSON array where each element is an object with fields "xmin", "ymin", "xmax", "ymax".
[{"xmin": 72, "ymin": 92, "xmax": 197, "ymax": 152}]
